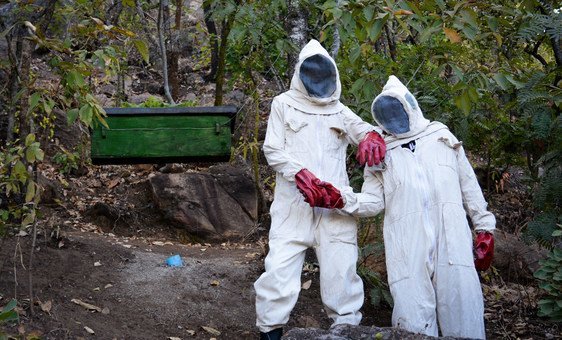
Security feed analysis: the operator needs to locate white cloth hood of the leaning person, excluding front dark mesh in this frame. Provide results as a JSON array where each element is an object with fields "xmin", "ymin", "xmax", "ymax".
[{"xmin": 371, "ymin": 76, "xmax": 429, "ymax": 139}]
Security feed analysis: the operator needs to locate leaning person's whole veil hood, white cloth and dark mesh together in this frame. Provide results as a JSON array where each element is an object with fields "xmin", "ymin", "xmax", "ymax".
[{"xmin": 371, "ymin": 76, "xmax": 429, "ymax": 138}]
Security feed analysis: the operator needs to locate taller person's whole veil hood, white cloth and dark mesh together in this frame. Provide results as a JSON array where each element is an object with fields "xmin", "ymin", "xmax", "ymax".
[{"xmin": 282, "ymin": 39, "xmax": 344, "ymax": 114}]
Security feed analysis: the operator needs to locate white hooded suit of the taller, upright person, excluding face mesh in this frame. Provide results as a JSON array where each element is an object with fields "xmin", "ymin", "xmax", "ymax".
[{"xmin": 254, "ymin": 40, "xmax": 375, "ymax": 332}]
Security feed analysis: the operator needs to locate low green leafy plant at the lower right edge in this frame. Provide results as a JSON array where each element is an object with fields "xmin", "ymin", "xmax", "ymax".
[{"xmin": 534, "ymin": 244, "xmax": 562, "ymax": 322}]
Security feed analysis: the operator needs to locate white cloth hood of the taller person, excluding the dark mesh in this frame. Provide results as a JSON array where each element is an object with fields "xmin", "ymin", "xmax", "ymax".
[{"xmin": 280, "ymin": 39, "xmax": 345, "ymax": 114}]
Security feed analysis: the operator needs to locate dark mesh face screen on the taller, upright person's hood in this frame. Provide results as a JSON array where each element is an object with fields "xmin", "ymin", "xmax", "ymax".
[{"xmin": 300, "ymin": 54, "xmax": 336, "ymax": 98}]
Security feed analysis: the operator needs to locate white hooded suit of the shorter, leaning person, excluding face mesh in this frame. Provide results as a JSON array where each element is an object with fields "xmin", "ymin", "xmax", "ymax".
[{"xmin": 342, "ymin": 76, "xmax": 495, "ymax": 338}]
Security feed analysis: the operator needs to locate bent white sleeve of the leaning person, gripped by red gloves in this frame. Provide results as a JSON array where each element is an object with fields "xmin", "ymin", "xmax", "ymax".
[{"xmin": 340, "ymin": 167, "xmax": 384, "ymax": 217}]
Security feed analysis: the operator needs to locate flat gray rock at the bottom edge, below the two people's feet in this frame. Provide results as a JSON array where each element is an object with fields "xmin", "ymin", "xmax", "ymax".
[{"xmin": 283, "ymin": 325, "xmax": 462, "ymax": 340}]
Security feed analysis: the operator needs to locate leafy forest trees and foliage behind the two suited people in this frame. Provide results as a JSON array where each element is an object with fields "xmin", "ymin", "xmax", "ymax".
[{"xmin": 0, "ymin": 0, "xmax": 562, "ymax": 338}]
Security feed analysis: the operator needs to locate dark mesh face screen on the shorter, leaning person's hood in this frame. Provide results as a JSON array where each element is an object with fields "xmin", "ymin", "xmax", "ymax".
[{"xmin": 372, "ymin": 96, "xmax": 410, "ymax": 134}]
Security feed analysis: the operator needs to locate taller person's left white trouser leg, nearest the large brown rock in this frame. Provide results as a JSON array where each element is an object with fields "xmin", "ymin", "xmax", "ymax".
[{"xmin": 254, "ymin": 238, "xmax": 308, "ymax": 332}]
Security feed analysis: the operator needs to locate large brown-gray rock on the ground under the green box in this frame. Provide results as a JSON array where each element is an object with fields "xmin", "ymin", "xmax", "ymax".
[{"xmin": 150, "ymin": 164, "xmax": 258, "ymax": 241}]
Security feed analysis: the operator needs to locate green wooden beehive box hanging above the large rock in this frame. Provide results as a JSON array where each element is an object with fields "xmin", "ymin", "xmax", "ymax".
[{"xmin": 91, "ymin": 106, "xmax": 236, "ymax": 164}]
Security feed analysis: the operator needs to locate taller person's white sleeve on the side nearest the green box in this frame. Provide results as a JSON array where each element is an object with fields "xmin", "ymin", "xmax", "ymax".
[{"xmin": 263, "ymin": 98, "xmax": 304, "ymax": 181}]
